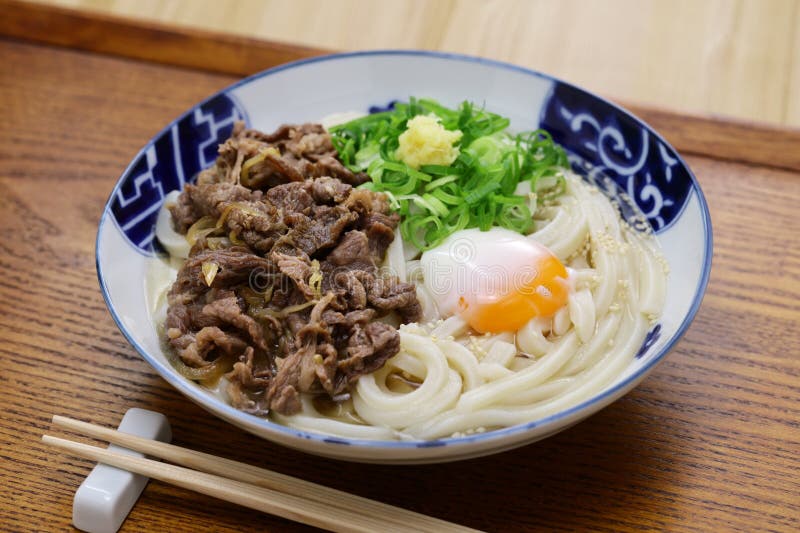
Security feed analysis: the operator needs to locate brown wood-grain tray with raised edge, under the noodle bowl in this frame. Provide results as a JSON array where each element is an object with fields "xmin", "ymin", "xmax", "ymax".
[{"xmin": 0, "ymin": 1, "xmax": 800, "ymax": 532}]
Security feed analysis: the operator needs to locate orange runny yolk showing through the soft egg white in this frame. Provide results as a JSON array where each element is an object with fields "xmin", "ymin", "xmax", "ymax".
[{"xmin": 458, "ymin": 249, "xmax": 569, "ymax": 333}]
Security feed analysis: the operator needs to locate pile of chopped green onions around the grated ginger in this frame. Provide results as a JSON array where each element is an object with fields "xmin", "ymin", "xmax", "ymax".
[{"xmin": 331, "ymin": 98, "xmax": 569, "ymax": 251}]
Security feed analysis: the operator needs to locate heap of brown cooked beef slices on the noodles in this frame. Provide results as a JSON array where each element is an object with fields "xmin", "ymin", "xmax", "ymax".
[{"xmin": 166, "ymin": 123, "xmax": 421, "ymax": 415}]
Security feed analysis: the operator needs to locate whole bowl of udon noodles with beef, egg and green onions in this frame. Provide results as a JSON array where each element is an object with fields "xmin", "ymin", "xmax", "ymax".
[{"xmin": 96, "ymin": 51, "xmax": 712, "ymax": 464}]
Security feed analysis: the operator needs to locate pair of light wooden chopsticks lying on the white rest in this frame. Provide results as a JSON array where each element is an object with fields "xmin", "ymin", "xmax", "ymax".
[{"xmin": 42, "ymin": 416, "xmax": 476, "ymax": 532}]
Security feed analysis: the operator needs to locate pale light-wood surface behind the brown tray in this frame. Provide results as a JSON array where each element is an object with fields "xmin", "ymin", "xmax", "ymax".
[{"xmin": 25, "ymin": 0, "xmax": 800, "ymax": 127}]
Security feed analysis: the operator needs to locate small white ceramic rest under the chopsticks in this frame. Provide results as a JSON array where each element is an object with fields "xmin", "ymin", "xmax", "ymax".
[{"xmin": 72, "ymin": 407, "xmax": 172, "ymax": 533}]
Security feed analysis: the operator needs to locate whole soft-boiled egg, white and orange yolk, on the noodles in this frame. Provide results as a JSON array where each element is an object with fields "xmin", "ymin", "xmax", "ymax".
[{"xmin": 421, "ymin": 228, "xmax": 569, "ymax": 333}]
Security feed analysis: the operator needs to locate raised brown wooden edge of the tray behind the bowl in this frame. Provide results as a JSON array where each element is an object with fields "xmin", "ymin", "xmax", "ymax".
[{"xmin": 0, "ymin": 0, "xmax": 800, "ymax": 170}]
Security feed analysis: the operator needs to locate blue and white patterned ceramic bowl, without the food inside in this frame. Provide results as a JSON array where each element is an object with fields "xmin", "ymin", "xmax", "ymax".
[{"xmin": 97, "ymin": 51, "xmax": 712, "ymax": 463}]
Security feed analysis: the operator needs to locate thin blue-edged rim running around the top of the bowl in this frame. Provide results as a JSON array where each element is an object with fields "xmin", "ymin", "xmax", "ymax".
[{"xmin": 95, "ymin": 49, "xmax": 713, "ymax": 450}]
